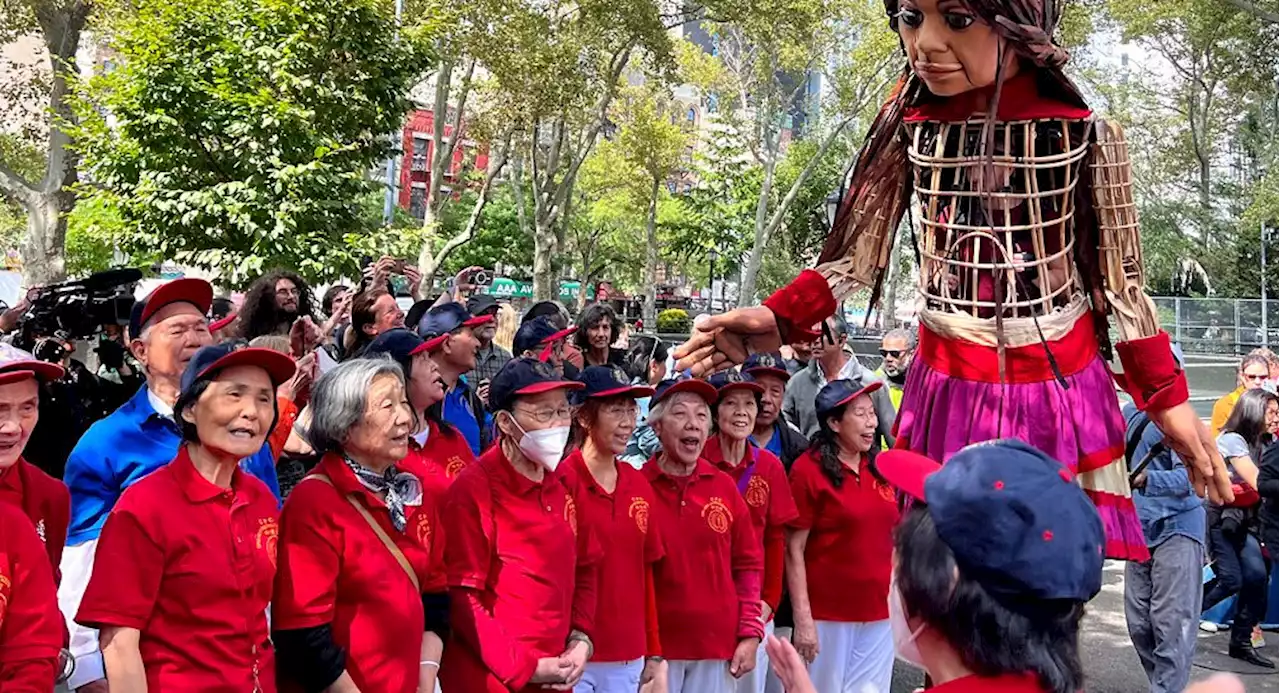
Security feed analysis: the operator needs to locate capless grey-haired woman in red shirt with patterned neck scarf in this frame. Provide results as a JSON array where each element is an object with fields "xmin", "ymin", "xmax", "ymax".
[{"xmin": 273, "ymin": 357, "xmax": 448, "ymax": 693}]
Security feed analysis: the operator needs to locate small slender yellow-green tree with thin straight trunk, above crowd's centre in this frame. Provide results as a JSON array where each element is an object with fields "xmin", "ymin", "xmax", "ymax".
[{"xmin": 618, "ymin": 82, "xmax": 691, "ymax": 324}]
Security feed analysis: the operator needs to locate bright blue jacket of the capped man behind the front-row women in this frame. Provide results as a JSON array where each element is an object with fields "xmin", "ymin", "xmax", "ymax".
[{"xmin": 63, "ymin": 384, "xmax": 280, "ymax": 546}]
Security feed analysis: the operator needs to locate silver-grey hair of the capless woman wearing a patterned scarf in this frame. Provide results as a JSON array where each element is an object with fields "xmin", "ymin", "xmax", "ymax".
[{"xmin": 306, "ymin": 354, "xmax": 404, "ymax": 453}]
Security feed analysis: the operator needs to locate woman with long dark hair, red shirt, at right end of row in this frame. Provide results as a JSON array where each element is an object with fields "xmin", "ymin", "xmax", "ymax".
[{"xmin": 787, "ymin": 380, "xmax": 899, "ymax": 690}]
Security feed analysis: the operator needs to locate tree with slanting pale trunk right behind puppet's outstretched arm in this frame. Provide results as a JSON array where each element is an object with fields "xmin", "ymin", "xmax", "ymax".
[{"xmin": 700, "ymin": 0, "xmax": 900, "ymax": 306}]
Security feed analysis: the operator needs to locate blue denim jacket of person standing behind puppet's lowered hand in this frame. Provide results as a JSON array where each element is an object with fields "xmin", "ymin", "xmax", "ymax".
[{"xmin": 1123, "ymin": 404, "xmax": 1204, "ymax": 548}]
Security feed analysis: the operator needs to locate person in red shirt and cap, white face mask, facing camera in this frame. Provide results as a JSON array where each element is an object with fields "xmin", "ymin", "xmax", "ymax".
[{"xmin": 440, "ymin": 357, "xmax": 603, "ymax": 693}]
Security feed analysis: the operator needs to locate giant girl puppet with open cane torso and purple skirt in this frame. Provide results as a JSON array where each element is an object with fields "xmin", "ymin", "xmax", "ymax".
[{"xmin": 676, "ymin": 0, "xmax": 1230, "ymax": 560}]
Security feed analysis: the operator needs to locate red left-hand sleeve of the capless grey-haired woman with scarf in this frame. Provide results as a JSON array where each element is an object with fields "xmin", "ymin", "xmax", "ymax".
[{"xmin": 271, "ymin": 480, "xmax": 343, "ymax": 630}]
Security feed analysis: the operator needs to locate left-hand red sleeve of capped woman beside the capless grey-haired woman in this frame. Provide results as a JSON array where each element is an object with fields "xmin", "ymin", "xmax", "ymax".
[{"xmin": 76, "ymin": 492, "xmax": 165, "ymax": 630}]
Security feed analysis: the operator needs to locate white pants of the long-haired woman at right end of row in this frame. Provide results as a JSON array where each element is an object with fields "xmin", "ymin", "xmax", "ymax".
[{"xmin": 809, "ymin": 620, "xmax": 893, "ymax": 693}]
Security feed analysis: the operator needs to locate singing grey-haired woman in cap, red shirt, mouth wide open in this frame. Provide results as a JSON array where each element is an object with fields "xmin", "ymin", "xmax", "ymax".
[{"xmin": 643, "ymin": 378, "xmax": 764, "ymax": 693}]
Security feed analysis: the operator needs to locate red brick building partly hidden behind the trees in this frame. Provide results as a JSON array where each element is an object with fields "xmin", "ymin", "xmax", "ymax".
[{"xmin": 397, "ymin": 108, "xmax": 489, "ymax": 219}]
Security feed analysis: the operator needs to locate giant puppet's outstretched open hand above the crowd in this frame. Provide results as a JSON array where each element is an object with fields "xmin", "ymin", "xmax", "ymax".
[{"xmin": 675, "ymin": 306, "xmax": 782, "ymax": 378}]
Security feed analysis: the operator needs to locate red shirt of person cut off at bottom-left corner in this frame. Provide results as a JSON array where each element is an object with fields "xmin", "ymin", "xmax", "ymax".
[{"xmin": 0, "ymin": 503, "xmax": 63, "ymax": 693}]
